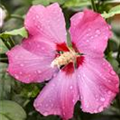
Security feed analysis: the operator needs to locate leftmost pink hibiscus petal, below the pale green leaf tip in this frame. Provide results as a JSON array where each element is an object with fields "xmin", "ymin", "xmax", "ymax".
[{"xmin": 7, "ymin": 37, "xmax": 57, "ymax": 83}]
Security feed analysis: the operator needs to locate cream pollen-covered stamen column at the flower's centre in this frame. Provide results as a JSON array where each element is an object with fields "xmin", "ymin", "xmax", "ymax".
[{"xmin": 51, "ymin": 50, "xmax": 79, "ymax": 67}]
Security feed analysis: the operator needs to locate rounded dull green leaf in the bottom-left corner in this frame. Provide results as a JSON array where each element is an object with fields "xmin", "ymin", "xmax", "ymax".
[{"xmin": 0, "ymin": 100, "xmax": 26, "ymax": 120}]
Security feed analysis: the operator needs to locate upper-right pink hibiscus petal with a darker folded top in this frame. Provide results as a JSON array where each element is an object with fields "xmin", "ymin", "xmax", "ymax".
[{"xmin": 70, "ymin": 10, "xmax": 111, "ymax": 57}]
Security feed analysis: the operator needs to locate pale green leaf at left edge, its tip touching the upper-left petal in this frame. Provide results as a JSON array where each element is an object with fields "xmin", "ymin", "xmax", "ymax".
[{"xmin": 0, "ymin": 27, "xmax": 28, "ymax": 39}]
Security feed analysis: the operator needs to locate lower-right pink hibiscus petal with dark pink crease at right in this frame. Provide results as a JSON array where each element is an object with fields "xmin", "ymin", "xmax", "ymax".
[{"xmin": 77, "ymin": 57, "xmax": 119, "ymax": 113}]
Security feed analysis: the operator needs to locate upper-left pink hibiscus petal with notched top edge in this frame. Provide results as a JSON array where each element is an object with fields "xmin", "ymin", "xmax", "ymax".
[{"xmin": 25, "ymin": 3, "xmax": 66, "ymax": 43}]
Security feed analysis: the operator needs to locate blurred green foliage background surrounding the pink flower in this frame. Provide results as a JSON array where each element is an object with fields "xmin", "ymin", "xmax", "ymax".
[{"xmin": 0, "ymin": 0, "xmax": 120, "ymax": 120}]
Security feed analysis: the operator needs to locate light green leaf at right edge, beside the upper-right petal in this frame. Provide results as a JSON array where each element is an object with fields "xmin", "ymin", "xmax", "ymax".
[{"xmin": 102, "ymin": 5, "xmax": 120, "ymax": 18}]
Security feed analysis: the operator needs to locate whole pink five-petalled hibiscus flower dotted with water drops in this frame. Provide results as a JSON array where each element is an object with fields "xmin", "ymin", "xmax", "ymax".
[{"xmin": 7, "ymin": 3, "xmax": 119, "ymax": 120}]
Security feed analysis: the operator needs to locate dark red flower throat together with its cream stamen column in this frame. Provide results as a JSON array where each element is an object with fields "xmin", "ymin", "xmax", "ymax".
[{"xmin": 51, "ymin": 43, "xmax": 84, "ymax": 74}]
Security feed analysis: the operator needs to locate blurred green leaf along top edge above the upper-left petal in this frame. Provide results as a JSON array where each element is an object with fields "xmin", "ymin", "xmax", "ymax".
[{"xmin": 32, "ymin": 0, "xmax": 66, "ymax": 6}]
